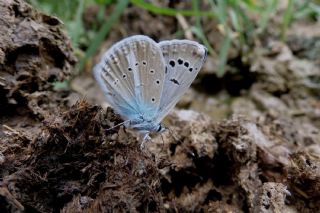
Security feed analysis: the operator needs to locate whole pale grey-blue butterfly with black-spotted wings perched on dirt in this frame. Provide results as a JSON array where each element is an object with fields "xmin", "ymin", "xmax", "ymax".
[{"xmin": 93, "ymin": 35, "xmax": 207, "ymax": 141}]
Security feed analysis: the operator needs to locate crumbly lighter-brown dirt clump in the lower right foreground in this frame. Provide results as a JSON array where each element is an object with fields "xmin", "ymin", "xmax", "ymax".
[{"xmin": 150, "ymin": 110, "xmax": 320, "ymax": 212}]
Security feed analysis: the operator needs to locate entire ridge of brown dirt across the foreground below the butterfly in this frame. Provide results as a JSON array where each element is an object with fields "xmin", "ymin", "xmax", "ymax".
[{"xmin": 0, "ymin": 101, "xmax": 319, "ymax": 212}]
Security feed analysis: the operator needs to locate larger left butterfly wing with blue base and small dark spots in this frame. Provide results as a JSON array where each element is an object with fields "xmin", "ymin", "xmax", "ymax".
[{"xmin": 94, "ymin": 35, "xmax": 165, "ymax": 120}]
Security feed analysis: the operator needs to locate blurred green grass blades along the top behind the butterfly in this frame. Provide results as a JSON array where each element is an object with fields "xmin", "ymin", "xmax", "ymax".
[{"xmin": 29, "ymin": 0, "xmax": 320, "ymax": 76}]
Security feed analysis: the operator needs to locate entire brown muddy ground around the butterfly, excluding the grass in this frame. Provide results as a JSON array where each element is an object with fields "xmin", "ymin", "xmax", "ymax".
[{"xmin": 0, "ymin": 0, "xmax": 320, "ymax": 212}]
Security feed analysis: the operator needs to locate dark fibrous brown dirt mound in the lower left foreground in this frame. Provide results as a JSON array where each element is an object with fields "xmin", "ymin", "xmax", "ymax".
[{"xmin": 0, "ymin": 101, "xmax": 161, "ymax": 212}]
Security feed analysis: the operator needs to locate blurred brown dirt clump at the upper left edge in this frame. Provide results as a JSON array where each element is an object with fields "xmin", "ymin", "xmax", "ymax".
[{"xmin": 0, "ymin": 0, "xmax": 76, "ymax": 122}]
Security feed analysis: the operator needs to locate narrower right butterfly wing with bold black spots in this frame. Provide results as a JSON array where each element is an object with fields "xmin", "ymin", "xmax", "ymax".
[{"xmin": 158, "ymin": 40, "xmax": 207, "ymax": 122}]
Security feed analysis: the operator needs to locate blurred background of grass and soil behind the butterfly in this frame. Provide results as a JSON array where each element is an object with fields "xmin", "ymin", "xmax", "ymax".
[{"xmin": 28, "ymin": 0, "xmax": 320, "ymax": 120}]
